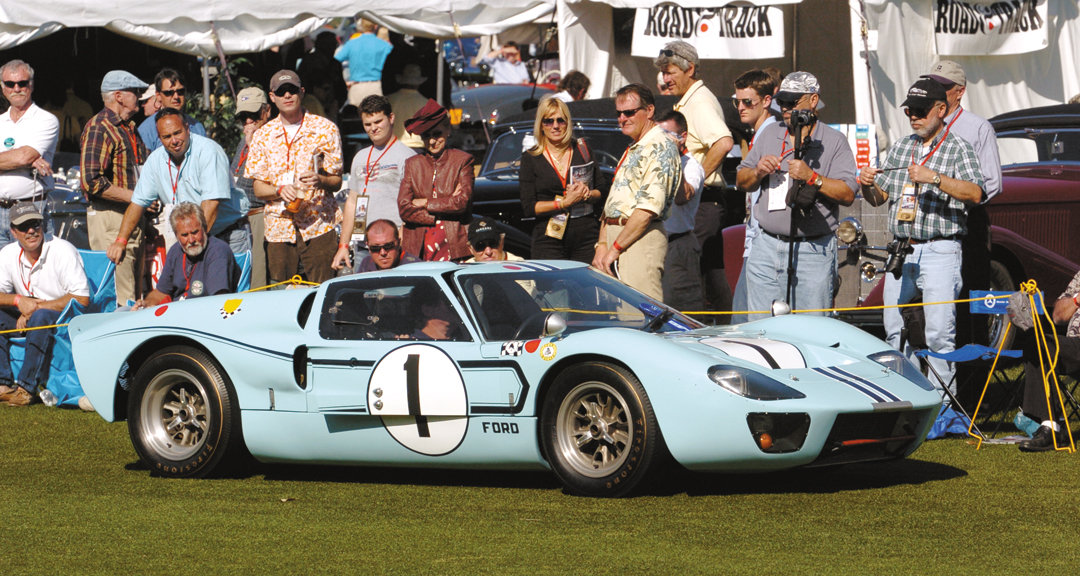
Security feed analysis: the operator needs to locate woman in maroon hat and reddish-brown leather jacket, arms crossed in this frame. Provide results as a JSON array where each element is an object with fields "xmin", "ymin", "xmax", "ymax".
[{"xmin": 397, "ymin": 99, "xmax": 473, "ymax": 262}]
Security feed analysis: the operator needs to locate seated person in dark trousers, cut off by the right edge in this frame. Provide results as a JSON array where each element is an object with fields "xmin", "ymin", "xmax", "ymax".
[{"xmin": 1020, "ymin": 272, "xmax": 1080, "ymax": 452}]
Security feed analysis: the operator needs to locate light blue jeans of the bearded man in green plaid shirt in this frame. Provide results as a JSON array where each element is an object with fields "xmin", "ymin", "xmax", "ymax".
[{"xmin": 882, "ymin": 240, "xmax": 963, "ymax": 393}]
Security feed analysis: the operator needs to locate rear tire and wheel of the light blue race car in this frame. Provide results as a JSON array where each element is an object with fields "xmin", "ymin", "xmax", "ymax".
[{"xmin": 127, "ymin": 346, "xmax": 246, "ymax": 478}]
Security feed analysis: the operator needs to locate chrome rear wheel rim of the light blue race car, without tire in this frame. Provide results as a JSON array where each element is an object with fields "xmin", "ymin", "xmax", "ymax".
[{"xmin": 139, "ymin": 370, "xmax": 212, "ymax": 460}]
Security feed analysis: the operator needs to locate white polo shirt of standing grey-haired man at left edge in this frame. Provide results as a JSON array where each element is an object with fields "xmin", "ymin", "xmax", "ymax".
[{"xmin": 0, "ymin": 102, "xmax": 60, "ymax": 200}]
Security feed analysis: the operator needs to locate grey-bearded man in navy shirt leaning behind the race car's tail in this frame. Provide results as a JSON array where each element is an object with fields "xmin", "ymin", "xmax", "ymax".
[{"xmin": 134, "ymin": 202, "xmax": 240, "ymax": 310}]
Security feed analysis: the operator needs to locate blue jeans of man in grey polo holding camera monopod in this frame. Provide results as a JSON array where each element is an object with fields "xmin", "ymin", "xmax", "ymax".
[{"xmin": 743, "ymin": 230, "xmax": 836, "ymax": 320}]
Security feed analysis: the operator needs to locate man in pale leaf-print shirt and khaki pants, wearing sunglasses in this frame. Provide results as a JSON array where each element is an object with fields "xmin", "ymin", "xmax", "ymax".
[{"xmin": 593, "ymin": 84, "xmax": 683, "ymax": 300}]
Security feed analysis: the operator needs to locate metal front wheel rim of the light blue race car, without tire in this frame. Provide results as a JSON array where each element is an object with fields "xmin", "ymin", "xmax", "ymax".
[{"xmin": 555, "ymin": 381, "xmax": 634, "ymax": 478}]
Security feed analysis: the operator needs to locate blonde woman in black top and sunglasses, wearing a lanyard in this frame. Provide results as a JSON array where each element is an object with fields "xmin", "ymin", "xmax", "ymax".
[{"xmin": 518, "ymin": 98, "xmax": 608, "ymax": 264}]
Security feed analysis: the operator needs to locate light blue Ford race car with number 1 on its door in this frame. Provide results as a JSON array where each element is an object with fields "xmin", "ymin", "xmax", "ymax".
[{"xmin": 70, "ymin": 262, "xmax": 941, "ymax": 496}]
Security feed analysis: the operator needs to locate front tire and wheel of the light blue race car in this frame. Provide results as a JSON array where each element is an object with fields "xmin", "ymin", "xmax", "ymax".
[{"xmin": 540, "ymin": 362, "xmax": 666, "ymax": 498}]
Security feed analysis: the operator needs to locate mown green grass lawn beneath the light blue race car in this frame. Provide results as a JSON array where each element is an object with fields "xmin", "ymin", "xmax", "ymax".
[{"xmin": 0, "ymin": 405, "xmax": 1080, "ymax": 575}]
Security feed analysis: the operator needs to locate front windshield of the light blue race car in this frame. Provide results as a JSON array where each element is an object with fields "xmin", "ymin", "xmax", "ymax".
[{"xmin": 457, "ymin": 263, "xmax": 702, "ymax": 341}]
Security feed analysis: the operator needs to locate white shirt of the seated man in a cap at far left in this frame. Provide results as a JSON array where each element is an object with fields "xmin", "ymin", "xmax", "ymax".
[{"xmin": 0, "ymin": 235, "xmax": 90, "ymax": 300}]
